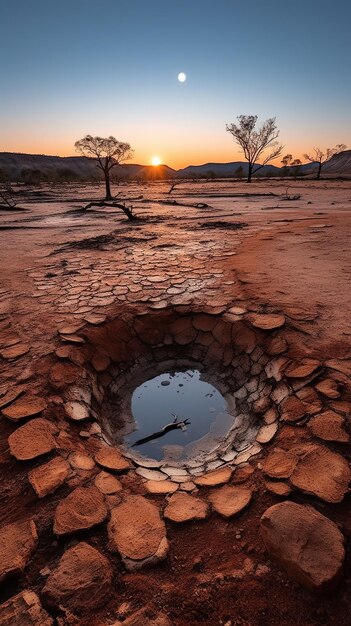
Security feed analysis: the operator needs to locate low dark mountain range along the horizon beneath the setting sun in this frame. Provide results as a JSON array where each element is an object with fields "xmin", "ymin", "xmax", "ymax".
[{"xmin": 0, "ymin": 150, "xmax": 351, "ymax": 182}]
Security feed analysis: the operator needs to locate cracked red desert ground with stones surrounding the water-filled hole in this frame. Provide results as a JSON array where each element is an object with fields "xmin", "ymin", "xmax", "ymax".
[{"xmin": 0, "ymin": 181, "xmax": 351, "ymax": 626}]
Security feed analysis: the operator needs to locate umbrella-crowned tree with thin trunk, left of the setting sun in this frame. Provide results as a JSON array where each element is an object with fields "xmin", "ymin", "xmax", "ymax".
[{"xmin": 74, "ymin": 135, "xmax": 133, "ymax": 200}]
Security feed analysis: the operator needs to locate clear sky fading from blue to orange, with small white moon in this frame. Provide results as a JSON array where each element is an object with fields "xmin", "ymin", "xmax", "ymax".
[{"xmin": 0, "ymin": 0, "xmax": 351, "ymax": 169}]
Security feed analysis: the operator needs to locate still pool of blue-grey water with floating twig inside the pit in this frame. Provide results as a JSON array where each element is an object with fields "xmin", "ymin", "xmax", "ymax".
[{"xmin": 126, "ymin": 370, "xmax": 233, "ymax": 460}]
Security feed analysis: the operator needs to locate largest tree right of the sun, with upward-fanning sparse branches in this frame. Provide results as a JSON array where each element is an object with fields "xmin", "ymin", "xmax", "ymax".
[{"xmin": 226, "ymin": 115, "xmax": 284, "ymax": 183}]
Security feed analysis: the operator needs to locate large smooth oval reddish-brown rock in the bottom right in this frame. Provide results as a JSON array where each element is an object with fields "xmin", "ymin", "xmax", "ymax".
[{"xmin": 261, "ymin": 502, "xmax": 345, "ymax": 592}]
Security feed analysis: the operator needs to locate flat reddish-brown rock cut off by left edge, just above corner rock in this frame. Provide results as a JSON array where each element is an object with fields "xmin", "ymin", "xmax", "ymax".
[{"xmin": 0, "ymin": 520, "xmax": 38, "ymax": 582}]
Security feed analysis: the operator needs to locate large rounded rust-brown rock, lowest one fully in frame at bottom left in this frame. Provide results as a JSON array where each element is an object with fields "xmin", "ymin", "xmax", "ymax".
[{"xmin": 42, "ymin": 542, "xmax": 112, "ymax": 613}]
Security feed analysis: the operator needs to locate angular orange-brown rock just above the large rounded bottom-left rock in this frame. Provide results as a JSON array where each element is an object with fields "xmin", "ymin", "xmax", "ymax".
[{"xmin": 54, "ymin": 487, "xmax": 107, "ymax": 535}]
